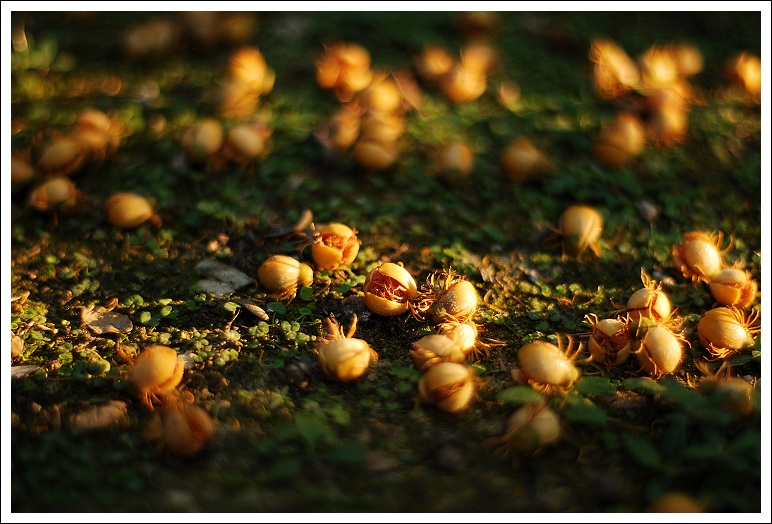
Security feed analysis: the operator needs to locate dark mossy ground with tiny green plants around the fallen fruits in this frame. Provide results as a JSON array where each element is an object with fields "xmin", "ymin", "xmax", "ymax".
[{"xmin": 3, "ymin": 8, "xmax": 769, "ymax": 518}]
